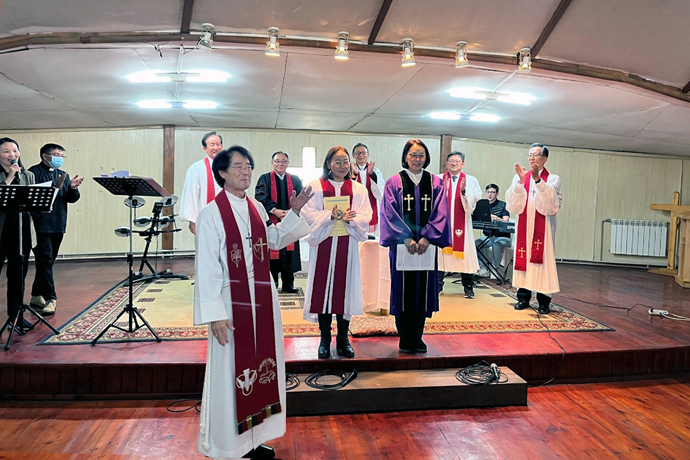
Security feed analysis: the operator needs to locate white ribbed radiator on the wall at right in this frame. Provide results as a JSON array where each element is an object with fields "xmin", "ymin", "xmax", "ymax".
[{"xmin": 611, "ymin": 219, "xmax": 668, "ymax": 257}]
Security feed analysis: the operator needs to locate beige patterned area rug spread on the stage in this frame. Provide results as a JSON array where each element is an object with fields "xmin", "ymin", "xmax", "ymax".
[{"xmin": 41, "ymin": 277, "xmax": 613, "ymax": 344}]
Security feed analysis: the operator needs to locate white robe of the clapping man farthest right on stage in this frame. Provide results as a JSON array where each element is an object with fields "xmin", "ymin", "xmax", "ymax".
[{"xmin": 506, "ymin": 171, "xmax": 562, "ymax": 295}]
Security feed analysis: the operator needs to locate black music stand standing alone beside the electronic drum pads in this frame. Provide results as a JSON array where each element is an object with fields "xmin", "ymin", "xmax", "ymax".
[{"xmin": 91, "ymin": 176, "xmax": 170, "ymax": 346}]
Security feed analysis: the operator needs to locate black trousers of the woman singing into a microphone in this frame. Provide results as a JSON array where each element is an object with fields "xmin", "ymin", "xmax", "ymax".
[{"xmin": 0, "ymin": 212, "xmax": 31, "ymax": 318}]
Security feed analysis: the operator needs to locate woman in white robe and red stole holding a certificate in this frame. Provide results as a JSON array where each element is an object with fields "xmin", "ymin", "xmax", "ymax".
[{"xmin": 302, "ymin": 145, "xmax": 371, "ymax": 359}]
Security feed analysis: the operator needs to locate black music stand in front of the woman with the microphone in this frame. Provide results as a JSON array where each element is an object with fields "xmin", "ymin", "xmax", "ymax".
[{"xmin": 0, "ymin": 185, "xmax": 59, "ymax": 350}]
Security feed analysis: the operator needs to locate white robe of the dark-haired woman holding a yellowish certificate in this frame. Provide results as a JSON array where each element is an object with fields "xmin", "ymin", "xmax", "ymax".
[{"xmin": 301, "ymin": 179, "xmax": 371, "ymax": 323}]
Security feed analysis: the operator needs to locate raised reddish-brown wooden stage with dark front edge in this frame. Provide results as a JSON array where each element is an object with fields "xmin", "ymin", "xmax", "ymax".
[{"xmin": 0, "ymin": 258, "xmax": 690, "ymax": 400}]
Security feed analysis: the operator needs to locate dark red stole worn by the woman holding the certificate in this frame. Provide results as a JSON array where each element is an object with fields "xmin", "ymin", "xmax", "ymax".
[{"xmin": 309, "ymin": 179, "xmax": 352, "ymax": 315}]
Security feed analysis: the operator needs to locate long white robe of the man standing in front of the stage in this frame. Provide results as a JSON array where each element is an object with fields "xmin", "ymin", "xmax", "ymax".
[{"xmin": 194, "ymin": 191, "xmax": 309, "ymax": 458}]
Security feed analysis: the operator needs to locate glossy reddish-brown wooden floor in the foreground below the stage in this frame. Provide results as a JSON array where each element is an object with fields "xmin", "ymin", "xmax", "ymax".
[{"xmin": 0, "ymin": 379, "xmax": 690, "ymax": 460}]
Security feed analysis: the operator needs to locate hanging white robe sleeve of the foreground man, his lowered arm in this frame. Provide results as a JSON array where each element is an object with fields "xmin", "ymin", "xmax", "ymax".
[{"xmin": 194, "ymin": 206, "xmax": 229, "ymax": 326}]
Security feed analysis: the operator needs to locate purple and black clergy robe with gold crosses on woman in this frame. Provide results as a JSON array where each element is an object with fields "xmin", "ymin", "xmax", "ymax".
[{"xmin": 379, "ymin": 170, "xmax": 451, "ymax": 318}]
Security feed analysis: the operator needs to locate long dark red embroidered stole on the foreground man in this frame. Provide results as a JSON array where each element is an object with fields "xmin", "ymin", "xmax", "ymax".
[{"xmin": 212, "ymin": 190, "xmax": 281, "ymax": 434}]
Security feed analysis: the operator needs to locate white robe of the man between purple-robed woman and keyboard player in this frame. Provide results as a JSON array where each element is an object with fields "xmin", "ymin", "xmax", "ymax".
[{"xmin": 438, "ymin": 174, "xmax": 482, "ymax": 273}]
